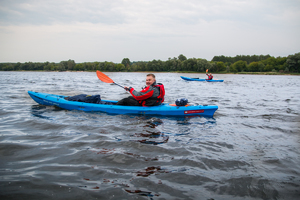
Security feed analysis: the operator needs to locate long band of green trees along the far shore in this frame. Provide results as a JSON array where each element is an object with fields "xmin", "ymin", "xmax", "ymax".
[{"xmin": 0, "ymin": 53, "xmax": 300, "ymax": 73}]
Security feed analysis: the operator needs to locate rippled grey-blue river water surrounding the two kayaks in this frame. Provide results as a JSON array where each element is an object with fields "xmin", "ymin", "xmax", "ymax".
[{"xmin": 0, "ymin": 72, "xmax": 300, "ymax": 200}]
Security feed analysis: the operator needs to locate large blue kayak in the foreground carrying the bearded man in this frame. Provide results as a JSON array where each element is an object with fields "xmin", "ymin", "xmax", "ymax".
[{"xmin": 28, "ymin": 91, "xmax": 218, "ymax": 117}]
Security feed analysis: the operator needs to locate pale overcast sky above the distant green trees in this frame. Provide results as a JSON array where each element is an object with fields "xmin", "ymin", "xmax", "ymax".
[{"xmin": 0, "ymin": 0, "xmax": 300, "ymax": 63}]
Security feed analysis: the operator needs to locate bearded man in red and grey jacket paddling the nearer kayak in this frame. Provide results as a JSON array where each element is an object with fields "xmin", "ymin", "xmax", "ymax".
[{"xmin": 117, "ymin": 74, "xmax": 165, "ymax": 106}]
